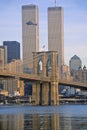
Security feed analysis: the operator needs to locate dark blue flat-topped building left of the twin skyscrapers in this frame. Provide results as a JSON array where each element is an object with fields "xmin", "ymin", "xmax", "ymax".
[{"xmin": 3, "ymin": 41, "xmax": 20, "ymax": 63}]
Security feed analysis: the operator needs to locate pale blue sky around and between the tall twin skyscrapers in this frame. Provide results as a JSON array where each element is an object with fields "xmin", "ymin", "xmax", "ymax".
[{"xmin": 0, "ymin": 0, "xmax": 87, "ymax": 66}]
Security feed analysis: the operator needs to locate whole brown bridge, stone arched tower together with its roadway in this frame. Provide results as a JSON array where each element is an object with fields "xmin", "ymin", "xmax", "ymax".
[{"xmin": 0, "ymin": 51, "xmax": 87, "ymax": 105}]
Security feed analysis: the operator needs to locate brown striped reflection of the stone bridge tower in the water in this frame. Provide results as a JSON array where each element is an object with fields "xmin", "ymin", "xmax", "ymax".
[{"xmin": 24, "ymin": 114, "xmax": 59, "ymax": 130}]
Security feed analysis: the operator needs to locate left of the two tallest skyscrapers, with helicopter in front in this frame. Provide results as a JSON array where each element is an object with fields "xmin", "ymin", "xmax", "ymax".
[{"xmin": 22, "ymin": 5, "xmax": 39, "ymax": 68}]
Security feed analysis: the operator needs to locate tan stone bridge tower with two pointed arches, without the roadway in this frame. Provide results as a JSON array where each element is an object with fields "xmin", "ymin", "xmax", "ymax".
[{"xmin": 32, "ymin": 51, "xmax": 59, "ymax": 105}]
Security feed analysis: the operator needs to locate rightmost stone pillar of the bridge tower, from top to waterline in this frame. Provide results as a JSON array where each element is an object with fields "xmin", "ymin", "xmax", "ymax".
[{"xmin": 50, "ymin": 52, "xmax": 59, "ymax": 105}]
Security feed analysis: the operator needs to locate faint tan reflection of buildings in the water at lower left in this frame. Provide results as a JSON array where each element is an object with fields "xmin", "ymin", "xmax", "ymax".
[{"xmin": 0, "ymin": 115, "xmax": 24, "ymax": 130}]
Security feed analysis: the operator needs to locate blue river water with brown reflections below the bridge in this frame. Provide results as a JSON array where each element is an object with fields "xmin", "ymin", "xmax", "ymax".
[{"xmin": 0, "ymin": 105, "xmax": 87, "ymax": 130}]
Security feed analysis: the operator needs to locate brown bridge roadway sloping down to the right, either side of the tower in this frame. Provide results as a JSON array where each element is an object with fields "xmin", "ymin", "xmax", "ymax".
[{"xmin": 0, "ymin": 70, "xmax": 87, "ymax": 89}]
